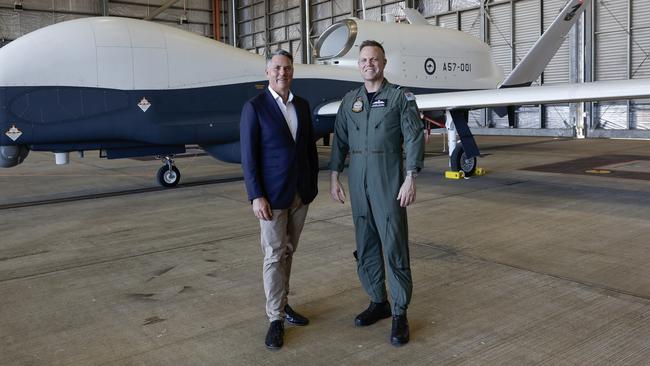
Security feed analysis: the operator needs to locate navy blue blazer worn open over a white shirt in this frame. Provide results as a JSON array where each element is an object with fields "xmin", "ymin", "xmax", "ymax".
[{"xmin": 239, "ymin": 88, "xmax": 318, "ymax": 209}]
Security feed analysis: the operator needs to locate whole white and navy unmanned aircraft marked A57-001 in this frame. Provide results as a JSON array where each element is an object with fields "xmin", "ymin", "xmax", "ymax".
[{"xmin": 0, "ymin": 0, "xmax": 650, "ymax": 187}]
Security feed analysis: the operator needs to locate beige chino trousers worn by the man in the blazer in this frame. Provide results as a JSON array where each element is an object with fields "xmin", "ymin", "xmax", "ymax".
[{"xmin": 260, "ymin": 194, "xmax": 309, "ymax": 322}]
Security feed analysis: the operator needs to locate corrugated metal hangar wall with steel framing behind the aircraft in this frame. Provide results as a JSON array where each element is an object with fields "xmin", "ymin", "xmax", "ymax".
[{"xmin": 0, "ymin": 0, "xmax": 650, "ymax": 138}]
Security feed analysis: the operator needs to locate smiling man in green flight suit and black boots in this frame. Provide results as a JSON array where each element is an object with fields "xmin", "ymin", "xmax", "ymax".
[{"xmin": 330, "ymin": 40, "xmax": 424, "ymax": 346}]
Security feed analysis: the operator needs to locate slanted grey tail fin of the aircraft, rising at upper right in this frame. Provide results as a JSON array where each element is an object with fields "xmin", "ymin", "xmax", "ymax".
[{"xmin": 499, "ymin": 0, "xmax": 591, "ymax": 88}]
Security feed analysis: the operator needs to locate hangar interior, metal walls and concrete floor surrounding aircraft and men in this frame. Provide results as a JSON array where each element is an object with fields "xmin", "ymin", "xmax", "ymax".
[{"xmin": 0, "ymin": 0, "xmax": 650, "ymax": 366}]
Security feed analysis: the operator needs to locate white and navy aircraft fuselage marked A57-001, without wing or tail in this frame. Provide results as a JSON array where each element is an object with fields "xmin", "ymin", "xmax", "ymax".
[{"xmin": 0, "ymin": 17, "xmax": 502, "ymax": 166}]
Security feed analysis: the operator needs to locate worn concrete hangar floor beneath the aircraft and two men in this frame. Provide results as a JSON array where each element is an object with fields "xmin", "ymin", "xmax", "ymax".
[{"xmin": 0, "ymin": 137, "xmax": 650, "ymax": 365}]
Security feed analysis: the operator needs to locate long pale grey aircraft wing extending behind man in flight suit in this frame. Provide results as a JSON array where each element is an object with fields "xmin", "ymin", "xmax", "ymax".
[{"xmin": 316, "ymin": 79, "xmax": 650, "ymax": 116}]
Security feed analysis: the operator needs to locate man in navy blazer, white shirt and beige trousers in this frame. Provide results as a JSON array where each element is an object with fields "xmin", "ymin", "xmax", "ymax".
[{"xmin": 240, "ymin": 50, "xmax": 318, "ymax": 349}]
